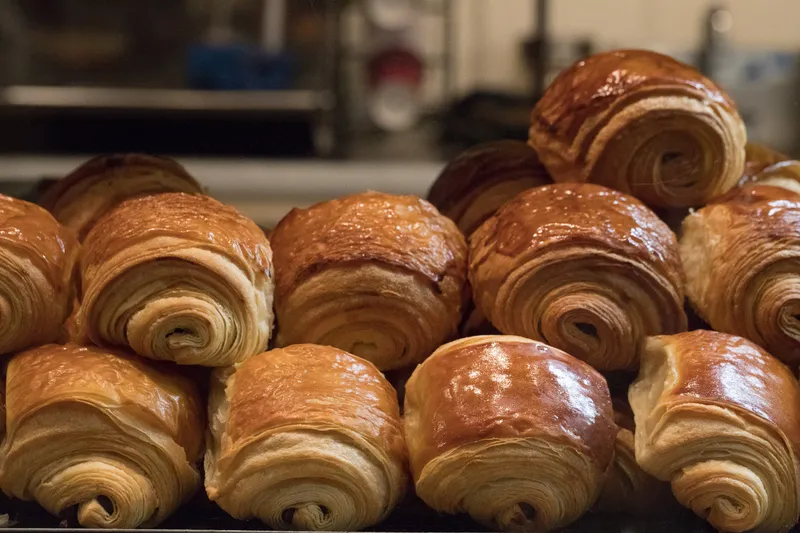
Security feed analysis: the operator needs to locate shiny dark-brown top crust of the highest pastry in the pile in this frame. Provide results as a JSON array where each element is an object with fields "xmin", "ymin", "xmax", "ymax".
[{"xmin": 531, "ymin": 50, "xmax": 736, "ymax": 145}]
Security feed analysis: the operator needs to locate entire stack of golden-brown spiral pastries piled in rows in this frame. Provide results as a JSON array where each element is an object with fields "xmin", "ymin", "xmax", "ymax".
[{"xmin": 0, "ymin": 45, "xmax": 800, "ymax": 532}]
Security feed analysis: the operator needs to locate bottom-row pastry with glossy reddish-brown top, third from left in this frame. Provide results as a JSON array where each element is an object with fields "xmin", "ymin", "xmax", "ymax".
[{"xmin": 405, "ymin": 335, "xmax": 617, "ymax": 531}]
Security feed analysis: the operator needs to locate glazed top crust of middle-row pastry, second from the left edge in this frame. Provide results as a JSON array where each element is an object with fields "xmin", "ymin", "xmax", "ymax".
[{"xmin": 81, "ymin": 193, "xmax": 272, "ymax": 277}]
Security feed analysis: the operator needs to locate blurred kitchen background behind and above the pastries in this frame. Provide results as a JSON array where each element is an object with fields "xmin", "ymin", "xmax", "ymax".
[{"xmin": 0, "ymin": 0, "xmax": 800, "ymax": 226}]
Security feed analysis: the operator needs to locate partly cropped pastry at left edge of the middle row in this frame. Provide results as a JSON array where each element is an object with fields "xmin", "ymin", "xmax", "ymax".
[{"xmin": 0, "ymin": 195, "xmax": 79, "ymax": 354}]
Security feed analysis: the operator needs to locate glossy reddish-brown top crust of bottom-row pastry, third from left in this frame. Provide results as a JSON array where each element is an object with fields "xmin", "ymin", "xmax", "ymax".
[{"xmin": 405, "ymin": 335, "xmax": 617, "ymax": 479}]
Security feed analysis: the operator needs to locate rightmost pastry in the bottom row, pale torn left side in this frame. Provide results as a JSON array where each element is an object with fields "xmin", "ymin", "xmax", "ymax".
[{"xmin": 629, "ymin": 330, "xmax": 800, "ymax": 532}]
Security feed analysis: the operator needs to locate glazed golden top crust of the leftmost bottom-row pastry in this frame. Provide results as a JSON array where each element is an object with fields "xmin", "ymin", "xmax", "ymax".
[{"xmin": 6, "ymin": 344, "xmax": 205, "ymax": 462}]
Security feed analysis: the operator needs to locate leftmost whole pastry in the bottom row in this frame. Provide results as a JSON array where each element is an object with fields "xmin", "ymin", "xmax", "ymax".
[{"xmin": 0, "ymin": 344, "xmax": 204, "ymax": 529}]
